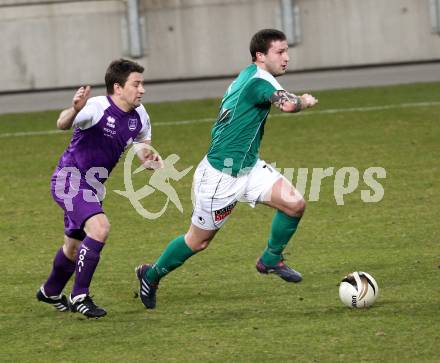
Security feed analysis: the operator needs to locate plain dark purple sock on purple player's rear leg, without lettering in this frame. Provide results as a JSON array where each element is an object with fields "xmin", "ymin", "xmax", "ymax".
[{"xmin": 43, "ymin": 247, "xmax": 75, "ymax": 296}]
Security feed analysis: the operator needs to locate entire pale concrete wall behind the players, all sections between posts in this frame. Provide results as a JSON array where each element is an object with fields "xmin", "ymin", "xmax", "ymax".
[{"xmin": 0, "ymin": 0, "xmax": 440, "ymax": 92}]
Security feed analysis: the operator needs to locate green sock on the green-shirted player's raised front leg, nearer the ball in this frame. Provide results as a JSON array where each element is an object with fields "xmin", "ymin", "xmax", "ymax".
[{"xmin": 261, "ymin": 211, "xmax": 301, "ymax": 266}]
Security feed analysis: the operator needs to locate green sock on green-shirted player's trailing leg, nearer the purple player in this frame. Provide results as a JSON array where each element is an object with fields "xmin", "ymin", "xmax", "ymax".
[{"xmin": 146, "ymin": 235, "xmax": 195, "ymax": 284}]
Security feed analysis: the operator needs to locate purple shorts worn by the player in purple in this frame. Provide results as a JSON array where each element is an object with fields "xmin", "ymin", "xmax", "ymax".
[{"xmin": 51, "ymin": 168, "xmax": 104, "ymax": 240}]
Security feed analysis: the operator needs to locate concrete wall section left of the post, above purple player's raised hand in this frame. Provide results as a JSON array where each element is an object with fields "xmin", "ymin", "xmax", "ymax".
[{"xmin": 0, "ymin": 1, "xmax": 125, "ymax": 91}]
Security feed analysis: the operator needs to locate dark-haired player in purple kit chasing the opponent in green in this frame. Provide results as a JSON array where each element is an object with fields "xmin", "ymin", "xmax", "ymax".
[{"xmin": 37, "ymin": 59, "xmax": 163, "ymax": 318}]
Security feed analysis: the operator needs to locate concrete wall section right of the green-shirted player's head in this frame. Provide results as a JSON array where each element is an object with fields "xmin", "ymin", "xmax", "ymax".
[{"xmin": 292, "ymin": 0, "xmax": 440, "ymax": 69}]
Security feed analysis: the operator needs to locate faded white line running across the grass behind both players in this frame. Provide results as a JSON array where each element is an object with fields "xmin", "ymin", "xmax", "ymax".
[{"xmin": 0, "ymin": 102, "xmax": 440, "ymax": 138}]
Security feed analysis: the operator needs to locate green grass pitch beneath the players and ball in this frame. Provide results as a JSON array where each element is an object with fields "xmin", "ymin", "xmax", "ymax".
[{"xmin": 0, "ymin": 83, "xmax": 440, "ymax": 362}]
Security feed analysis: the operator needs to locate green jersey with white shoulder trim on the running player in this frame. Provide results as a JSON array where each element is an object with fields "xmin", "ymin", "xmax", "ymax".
[{"xmin": 207, "ymin": 64, "xmax": 283, "ymax": 176}]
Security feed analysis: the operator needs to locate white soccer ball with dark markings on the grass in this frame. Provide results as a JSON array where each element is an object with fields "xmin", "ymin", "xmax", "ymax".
[{"xmin": 339, "ymin": 271, "xmax": 379, "ymax": 309}]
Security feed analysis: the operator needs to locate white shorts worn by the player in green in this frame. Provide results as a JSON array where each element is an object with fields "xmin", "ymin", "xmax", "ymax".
[{"xmin": 191, "ymin": 157, "xmax": 282, "ymax": 230}]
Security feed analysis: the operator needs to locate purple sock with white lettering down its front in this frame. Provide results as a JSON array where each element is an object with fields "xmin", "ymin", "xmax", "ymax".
[{"xmin": 72, "ymin": 236, "xmax": 104, "ymax": 297}]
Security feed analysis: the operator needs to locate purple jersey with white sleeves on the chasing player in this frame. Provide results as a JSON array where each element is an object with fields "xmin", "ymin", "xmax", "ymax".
[{"xmin": 55, "ymin": 96, "xmax": 151, "ymax": 183}]
